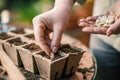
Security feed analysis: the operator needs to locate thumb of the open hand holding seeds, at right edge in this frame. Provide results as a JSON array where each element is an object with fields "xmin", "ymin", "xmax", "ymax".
[{"xmin": 106, "ymin": 19, "xmax": 120, "ymax": 36}]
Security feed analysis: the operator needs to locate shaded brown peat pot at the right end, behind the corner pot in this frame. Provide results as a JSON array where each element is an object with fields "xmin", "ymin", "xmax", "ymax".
[{"xmin": 59, "ymin": 44, "xmax": 84, "ymax": 77}]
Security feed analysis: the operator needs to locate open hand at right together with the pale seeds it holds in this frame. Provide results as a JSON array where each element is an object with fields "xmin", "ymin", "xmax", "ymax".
[{"xmin": 79, "ymin": 0, "xmax": 120, "ymax": 36}]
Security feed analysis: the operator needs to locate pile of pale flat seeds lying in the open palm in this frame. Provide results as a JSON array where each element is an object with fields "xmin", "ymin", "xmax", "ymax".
[{"xmin": 95, "ymin": 13, "xmax": 115, "ymax": 27}]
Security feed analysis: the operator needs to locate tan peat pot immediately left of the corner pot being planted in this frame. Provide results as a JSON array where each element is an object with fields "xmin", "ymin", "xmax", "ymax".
[{"xmin": 18, "ymin": 43, "xmax": 41, "ymax": 73}]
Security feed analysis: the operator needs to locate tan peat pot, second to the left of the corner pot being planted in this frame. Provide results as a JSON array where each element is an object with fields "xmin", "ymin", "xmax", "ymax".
[{"xmin": 4, "ymin": 37, "xmax": 27, "ymax": 66}]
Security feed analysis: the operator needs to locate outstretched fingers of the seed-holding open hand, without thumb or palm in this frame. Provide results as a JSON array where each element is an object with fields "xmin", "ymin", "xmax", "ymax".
[{"xmin": 79, "ymin": 15, "xmax": 108, "ymax": 34}]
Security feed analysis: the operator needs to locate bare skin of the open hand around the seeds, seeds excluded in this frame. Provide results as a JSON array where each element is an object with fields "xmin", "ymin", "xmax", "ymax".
[{"xmin": 79, "ymin": 0, "xmax": 120, "ymax": 36}]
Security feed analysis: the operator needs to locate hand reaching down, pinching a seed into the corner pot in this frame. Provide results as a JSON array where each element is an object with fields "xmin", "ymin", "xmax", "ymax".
[{"xmin": 33, "ymin": 0, "xmax": 74, "ymax": 55}]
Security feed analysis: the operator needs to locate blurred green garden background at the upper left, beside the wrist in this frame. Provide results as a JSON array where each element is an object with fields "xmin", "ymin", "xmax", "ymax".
[{"xmin": 0, "ymin": 0, "xmax": 54, "ymax": 24}]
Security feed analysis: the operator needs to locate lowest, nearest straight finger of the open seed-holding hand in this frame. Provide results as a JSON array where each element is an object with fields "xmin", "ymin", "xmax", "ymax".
[{"xmin": 82, "ymin": 27, "xmax": 107, "ymax": 34}]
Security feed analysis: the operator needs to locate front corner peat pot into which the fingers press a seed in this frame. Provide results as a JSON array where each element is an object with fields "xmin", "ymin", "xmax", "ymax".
[{"xmin": 33, "ymin": 52, "xmax": 68, "ymax": 80}]
